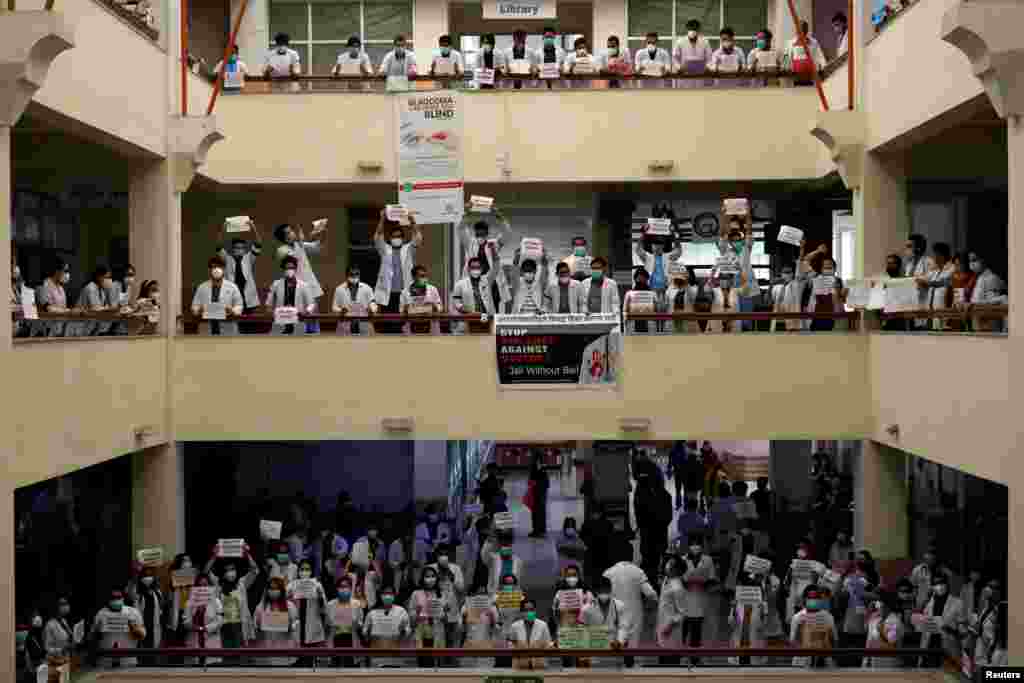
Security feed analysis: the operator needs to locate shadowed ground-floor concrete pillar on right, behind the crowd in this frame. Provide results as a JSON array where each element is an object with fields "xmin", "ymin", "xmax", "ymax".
[{"xmin": 853, "ymin": 440, "xmax": 910, "ymax": 560}]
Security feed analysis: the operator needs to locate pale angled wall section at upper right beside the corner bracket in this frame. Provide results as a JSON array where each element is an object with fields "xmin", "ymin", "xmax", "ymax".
[{"xmin": 861, "ymin": 0, "xmax": 982, "ymax": 148}]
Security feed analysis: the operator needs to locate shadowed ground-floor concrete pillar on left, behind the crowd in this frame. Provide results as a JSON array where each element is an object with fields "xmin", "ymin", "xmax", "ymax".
[{"xmin": 131, "ymin": 443, "xmax": 185, "ymax": 562}]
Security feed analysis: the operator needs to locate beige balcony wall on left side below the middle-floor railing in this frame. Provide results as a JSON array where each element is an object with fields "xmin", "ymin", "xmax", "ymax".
[{"xmin": 5, "ymin": 337, "xmax": 168, "ymax": 487}]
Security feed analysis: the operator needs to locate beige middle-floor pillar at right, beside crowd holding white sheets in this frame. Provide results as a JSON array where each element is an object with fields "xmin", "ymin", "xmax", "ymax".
[{"xmin": 853, "ymin": 152, "xmax": 910, "ymax": 278}]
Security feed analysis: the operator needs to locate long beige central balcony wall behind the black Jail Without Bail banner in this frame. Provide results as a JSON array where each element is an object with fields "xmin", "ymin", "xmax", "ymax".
[{"xmin": 173, "ymin": 335, "xmax": 872, "ymax": 441}]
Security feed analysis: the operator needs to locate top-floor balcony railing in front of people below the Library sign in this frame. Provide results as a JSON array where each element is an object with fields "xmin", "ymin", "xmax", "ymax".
[{"xmin": 235, "ymin": 71, "xmax": 794, "ymax": 94}]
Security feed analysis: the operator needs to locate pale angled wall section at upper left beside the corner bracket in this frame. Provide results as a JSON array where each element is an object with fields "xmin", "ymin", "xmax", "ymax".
[{"xmin": 17, "ymin": 0, "xmax": 168, "ymax": 155}]
